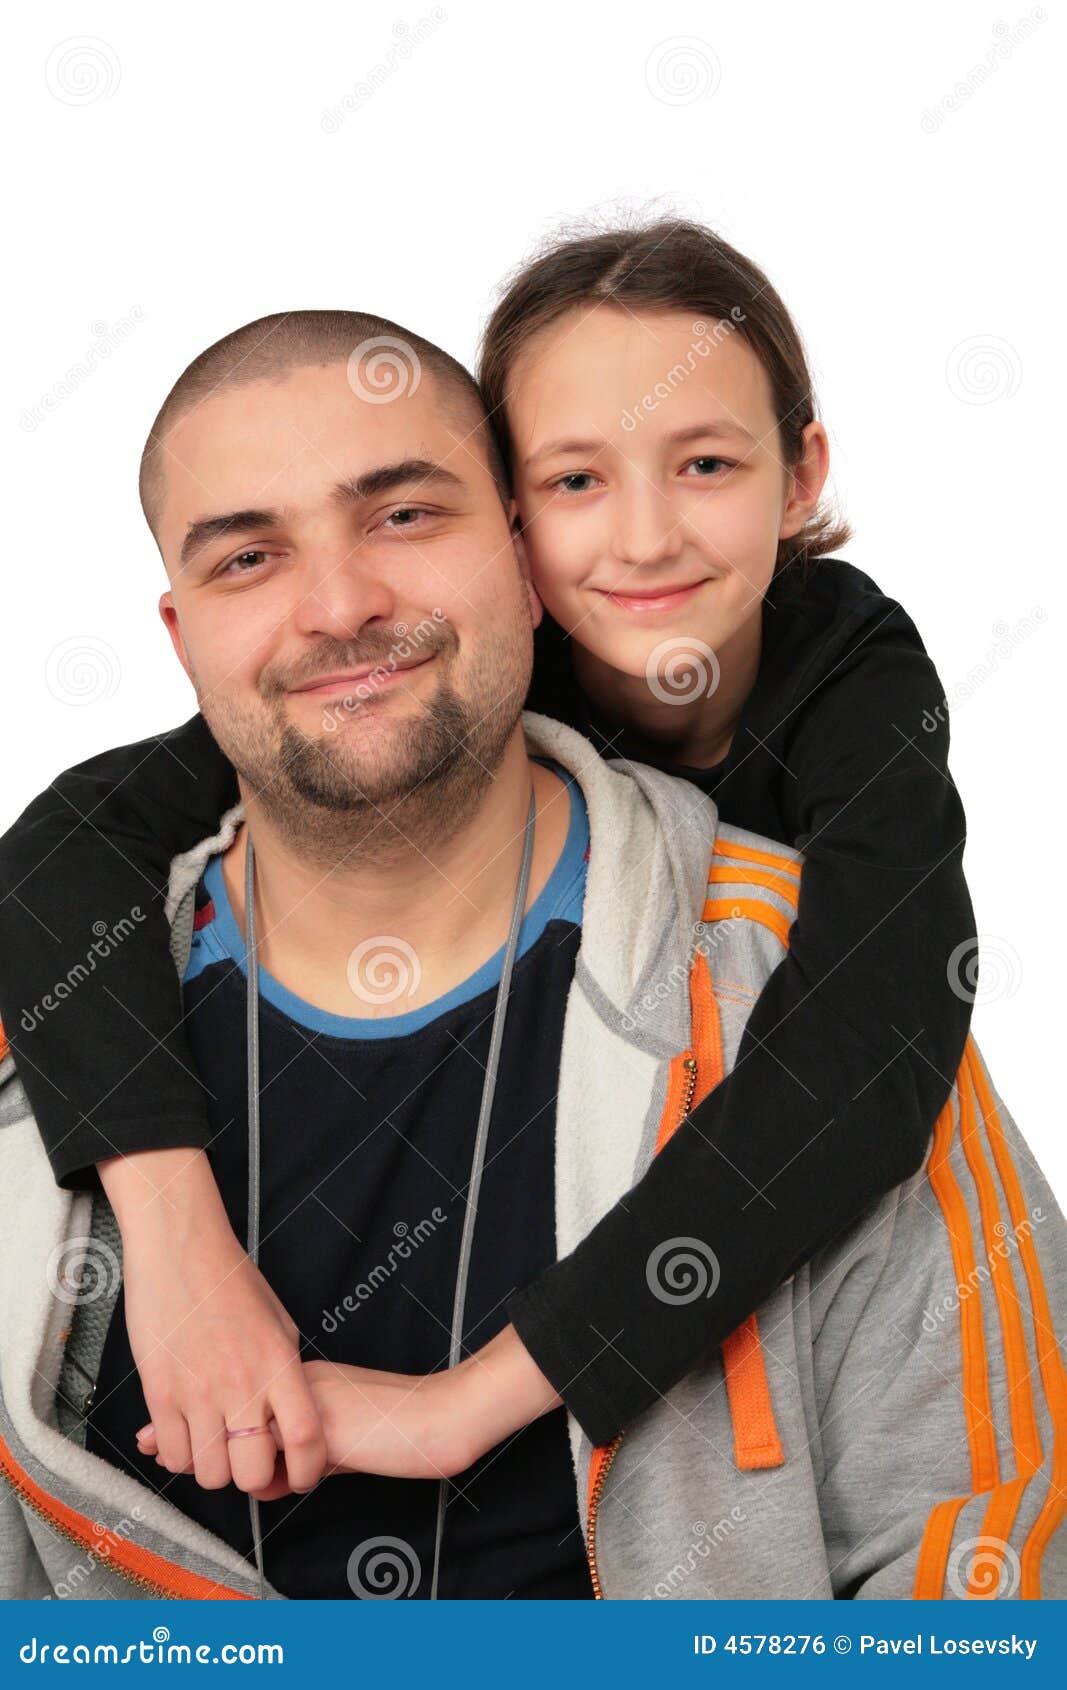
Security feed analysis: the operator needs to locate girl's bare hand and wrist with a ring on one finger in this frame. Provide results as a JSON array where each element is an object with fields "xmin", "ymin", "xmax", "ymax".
[{"xmin": 98, "ymin": 1148, "xmax": 326, "ymax": 1494}]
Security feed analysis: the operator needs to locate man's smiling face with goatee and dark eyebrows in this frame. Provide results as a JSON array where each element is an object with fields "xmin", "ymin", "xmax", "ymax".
[{"xmin": 159, "ymin": 362, "xmax": 539, "ymax": 828}]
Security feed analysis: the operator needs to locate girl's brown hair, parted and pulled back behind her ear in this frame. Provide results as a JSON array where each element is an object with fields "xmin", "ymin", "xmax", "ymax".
[{"xmin": 479, "ymin": 218, "xmax": 852, "ymax": 575}]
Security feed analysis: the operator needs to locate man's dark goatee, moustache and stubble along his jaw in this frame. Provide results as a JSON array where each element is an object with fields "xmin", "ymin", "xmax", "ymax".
[{"xmin": 198, "ymin": 624, "xmax": 531, "ymax": 867}]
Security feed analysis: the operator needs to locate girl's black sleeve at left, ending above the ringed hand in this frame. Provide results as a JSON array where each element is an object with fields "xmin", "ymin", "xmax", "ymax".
[{"xmin": 0, "ymin": 715, "xmax": 238, "ymax": 1190}]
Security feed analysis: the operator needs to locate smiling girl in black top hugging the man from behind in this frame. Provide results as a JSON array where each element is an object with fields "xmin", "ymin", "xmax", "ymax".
[{"xmin": 0, "ymin": 221, "xmax": 974, "ymax": 1493}]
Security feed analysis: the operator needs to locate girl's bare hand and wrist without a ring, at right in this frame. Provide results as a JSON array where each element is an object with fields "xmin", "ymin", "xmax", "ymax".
[{"xmin": 139, "ymin": 1327, "xmax": 561, "ymax": 1502}]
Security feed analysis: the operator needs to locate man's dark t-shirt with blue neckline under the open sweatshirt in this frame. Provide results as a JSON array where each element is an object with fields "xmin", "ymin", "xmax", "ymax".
[{"xmin": 88, "ymin": 771, "xmax": 592, "ymax": 1599}]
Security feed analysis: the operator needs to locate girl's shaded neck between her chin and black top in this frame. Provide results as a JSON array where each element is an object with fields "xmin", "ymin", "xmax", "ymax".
[{"xmin": 572, "ymin": 603, "xmax": 763, "ymax": 769}]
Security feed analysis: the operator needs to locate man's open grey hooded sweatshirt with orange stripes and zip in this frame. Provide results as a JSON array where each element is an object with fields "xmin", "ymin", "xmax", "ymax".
[{"xmin": 0, "ymin": 713, "xmax": 1067, "ymax": 1600}]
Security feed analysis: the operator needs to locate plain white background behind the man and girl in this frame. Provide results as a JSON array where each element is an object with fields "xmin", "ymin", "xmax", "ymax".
[{"xmin": 0, "ymin": 0, "xmax": 1067, "ymax": 1203}]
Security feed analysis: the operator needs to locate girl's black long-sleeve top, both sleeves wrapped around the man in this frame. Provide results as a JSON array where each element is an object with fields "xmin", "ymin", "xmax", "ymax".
[{"xmin": 0, "ymin": 559, "xmax": 976, "ymax": 1443}]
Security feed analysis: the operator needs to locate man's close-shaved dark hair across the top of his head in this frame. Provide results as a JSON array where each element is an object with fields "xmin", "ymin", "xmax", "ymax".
[{"xmin": 139, "ymin": 311, "xmax": 509, "ymax": 541}]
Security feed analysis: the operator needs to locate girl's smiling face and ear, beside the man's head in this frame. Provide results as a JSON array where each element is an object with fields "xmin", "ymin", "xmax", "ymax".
[{"xmin": 507, "ymin": 304, "xmax": 829, "ymax": 678}]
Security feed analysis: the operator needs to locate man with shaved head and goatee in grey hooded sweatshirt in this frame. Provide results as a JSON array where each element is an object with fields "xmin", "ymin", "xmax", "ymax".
[{"xmin": 0, "ymin": 313, "xmax": 1064, "ymax": 1597}]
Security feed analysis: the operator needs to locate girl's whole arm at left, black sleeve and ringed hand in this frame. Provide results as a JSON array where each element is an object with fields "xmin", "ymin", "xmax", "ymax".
[{"xmin": 0, "ymin": 717, "xmax": 325, "ymax": 1489}]
